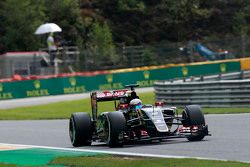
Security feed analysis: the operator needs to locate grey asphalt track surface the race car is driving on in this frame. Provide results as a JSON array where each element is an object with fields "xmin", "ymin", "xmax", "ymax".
[{"xmin": 0, "ymin": 114, "xmax": 250, "ymax": 162}]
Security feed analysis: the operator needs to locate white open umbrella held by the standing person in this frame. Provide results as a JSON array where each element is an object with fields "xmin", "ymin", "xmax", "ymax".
[{"xmin": 35, "ymin": 23, "xmax": 62, "ymax": 34}]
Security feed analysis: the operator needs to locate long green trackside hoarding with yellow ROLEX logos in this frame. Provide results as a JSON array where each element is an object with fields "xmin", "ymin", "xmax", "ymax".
[{"xmin": 0, "ymin": 60, "xmax": 242, "ymax": 100}]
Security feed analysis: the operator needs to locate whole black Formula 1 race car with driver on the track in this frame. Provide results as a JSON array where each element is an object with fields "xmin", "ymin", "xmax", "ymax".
[{"xmin": 69, "ymin": 85, "xmax": 209, "ymax": 147}]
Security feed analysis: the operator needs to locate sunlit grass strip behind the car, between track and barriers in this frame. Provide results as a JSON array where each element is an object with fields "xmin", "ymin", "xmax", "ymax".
[{"xmin": 0, "ymin": 92, "xmax": 250, "ymax": 120}]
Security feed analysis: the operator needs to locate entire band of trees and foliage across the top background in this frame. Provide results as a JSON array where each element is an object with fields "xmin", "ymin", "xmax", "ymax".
[{"xmin": 0, "ymin": 0, "xmax": 250, "ymax": 54}]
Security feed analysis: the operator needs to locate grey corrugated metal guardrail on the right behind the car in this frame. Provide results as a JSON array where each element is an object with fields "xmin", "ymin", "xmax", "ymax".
[{"xmin": 154, "ymin": 71, "xmax": 250, "ymax": 107}]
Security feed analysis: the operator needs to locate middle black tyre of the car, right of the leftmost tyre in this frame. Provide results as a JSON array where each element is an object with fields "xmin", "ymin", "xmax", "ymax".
[{"xmin": 105, "ymin": 111, "xmax": 126, "ymax": 147}]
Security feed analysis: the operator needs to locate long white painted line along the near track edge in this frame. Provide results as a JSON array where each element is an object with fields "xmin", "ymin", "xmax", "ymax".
[{"xmin": 0, "ymin": 143, "xmax": 250, "ymax": 163}]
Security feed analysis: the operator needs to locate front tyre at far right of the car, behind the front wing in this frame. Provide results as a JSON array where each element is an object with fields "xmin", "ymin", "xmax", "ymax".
[{"xmin": 182, "ymin": 105, "xmax": 205, "ymax": 141}]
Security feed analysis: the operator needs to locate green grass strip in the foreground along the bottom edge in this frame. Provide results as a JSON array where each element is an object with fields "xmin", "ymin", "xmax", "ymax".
[{"xmin": 51, "ymin": 156, "xmax": 249, "ymax": 167}]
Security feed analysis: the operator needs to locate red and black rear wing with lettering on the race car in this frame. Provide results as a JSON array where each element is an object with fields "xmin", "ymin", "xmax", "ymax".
[{"xmin": 90, "ymin": 89, "xmax": 128, "ymax": 121}]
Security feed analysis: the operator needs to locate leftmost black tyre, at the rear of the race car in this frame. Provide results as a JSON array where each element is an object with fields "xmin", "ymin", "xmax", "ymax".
[{"xmin": 69, "ymin": 112, "xmax": 92, "ymax": 147}]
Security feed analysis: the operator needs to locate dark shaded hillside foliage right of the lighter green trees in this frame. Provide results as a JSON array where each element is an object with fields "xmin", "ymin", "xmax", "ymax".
[{"xmin": 90, "ymin": 0, "xmax": 250, "ymax": 45}]
